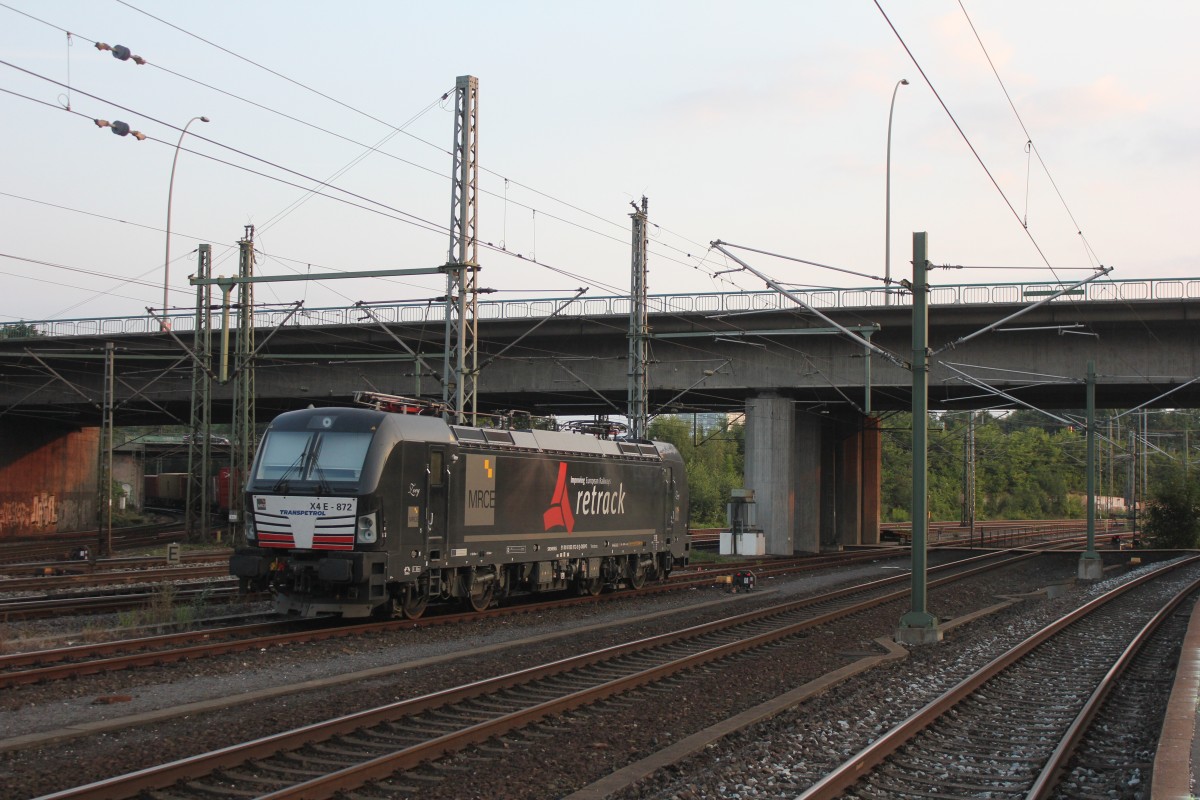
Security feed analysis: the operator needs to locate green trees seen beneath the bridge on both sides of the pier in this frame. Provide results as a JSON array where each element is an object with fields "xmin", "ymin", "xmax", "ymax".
[{"xmin": 650, "ymin": 410, "xmax": 1200, "ymax": 527}]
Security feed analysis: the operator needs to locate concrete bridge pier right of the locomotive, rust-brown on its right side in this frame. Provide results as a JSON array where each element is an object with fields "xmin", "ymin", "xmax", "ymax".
[{"xmin": 745, "ymin": 393, "xmax": 882, "ymax": 555}]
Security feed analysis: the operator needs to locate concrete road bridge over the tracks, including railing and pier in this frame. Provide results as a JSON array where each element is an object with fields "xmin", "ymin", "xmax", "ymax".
[{"xmin": 0, "ymin": 278, "xmax": 1200, "ymax": 553}]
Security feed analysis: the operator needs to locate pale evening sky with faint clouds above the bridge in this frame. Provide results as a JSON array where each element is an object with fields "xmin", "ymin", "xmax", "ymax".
[{"xmin": 0, "ymin": 0, "xmax": 1200, "ymax": 323}]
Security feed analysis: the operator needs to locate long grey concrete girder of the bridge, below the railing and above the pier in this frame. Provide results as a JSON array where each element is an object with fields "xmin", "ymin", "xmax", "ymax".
[{"xmin": 0, "ymin": 300, "xmax": 1200, "ymax": 426}]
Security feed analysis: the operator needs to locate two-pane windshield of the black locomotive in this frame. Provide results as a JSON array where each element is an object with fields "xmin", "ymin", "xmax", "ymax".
[{"xmin": 254, "ymin": 431, "xmax": 374, "ymax": 486}]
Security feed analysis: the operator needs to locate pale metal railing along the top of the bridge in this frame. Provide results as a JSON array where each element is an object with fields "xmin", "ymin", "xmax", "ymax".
[{"xmin": 0, "ymin": 278, "xmax": 1200, "ymax": 338}]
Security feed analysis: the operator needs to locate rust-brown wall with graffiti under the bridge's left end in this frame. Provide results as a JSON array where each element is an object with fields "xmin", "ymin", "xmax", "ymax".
[{"xmin": 0, "ymin": 420, "xmax": 100, "ymax": 539}]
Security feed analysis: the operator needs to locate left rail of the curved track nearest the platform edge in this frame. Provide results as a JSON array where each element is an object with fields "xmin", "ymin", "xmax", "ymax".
[{"xmin": 798, "ymin": 555, "xmax": 1200, "ymax": 800}]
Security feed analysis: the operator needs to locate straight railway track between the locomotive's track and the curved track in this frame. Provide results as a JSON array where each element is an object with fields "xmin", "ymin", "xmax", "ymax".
[{"xmin": 30, "ymin": 553, "xmax": 1037, "ymax": 798}]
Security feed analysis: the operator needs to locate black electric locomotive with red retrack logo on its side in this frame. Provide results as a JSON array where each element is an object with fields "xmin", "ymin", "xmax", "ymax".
[{"xmin": 230, "ymin": 400, "xmax": 689, "ymax": 618}]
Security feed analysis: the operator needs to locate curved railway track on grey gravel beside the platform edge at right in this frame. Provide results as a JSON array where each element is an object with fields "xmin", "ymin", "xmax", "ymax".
[{"xmin": 800, "ymin": 557, "xmax": 1200, "ymax": 800}]
